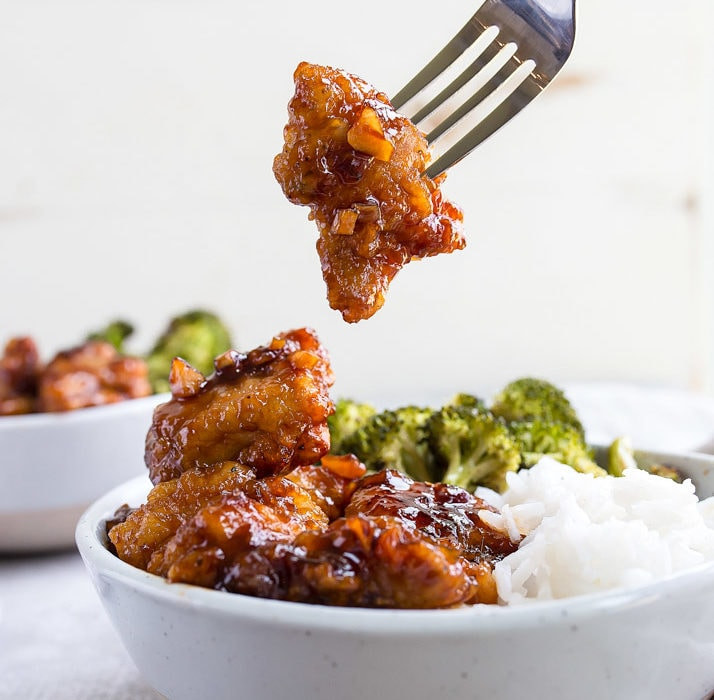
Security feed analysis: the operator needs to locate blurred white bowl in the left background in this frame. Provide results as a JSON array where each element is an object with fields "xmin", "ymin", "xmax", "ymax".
[{"xmin": 0, "ymin": 394, "xmax": 168, "ymax": 553}]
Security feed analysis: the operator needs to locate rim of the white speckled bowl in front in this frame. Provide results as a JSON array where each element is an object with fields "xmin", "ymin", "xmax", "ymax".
[{"xmin": 75, "ymin": 462, "xmax": 714, "ymax": 636}]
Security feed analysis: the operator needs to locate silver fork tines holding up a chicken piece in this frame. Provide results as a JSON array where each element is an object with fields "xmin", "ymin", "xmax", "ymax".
[{"xmin": 392, "ymin": 0, "xmax": 575, "ymax": 178}]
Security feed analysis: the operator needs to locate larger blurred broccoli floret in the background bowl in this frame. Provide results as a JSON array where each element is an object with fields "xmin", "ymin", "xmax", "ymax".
[{"xmin": 146, "ymin": 310, "xmax": 232, "ymax": 394}]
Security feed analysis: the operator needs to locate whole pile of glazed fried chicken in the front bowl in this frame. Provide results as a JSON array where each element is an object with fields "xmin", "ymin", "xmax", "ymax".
[{"xmin": 107, "ymin": 329, "xmax": 517, "ymax": 609}]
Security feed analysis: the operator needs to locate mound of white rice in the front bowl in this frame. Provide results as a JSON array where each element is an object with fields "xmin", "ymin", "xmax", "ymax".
[{"xmin": 476, "ymin": 458, "xmax": 714, "ymax": 605}]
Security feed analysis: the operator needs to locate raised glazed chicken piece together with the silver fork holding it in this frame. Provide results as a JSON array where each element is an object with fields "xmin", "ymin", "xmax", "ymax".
[{"xmin": 273, "ymin": 0, "xmax": 575, "ymax": 323}]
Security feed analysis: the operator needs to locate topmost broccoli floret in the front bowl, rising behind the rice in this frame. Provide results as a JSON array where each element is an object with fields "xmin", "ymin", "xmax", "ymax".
[{"xmin": 491, "ymin": 377, "xmax": 585, "ymax": 439}]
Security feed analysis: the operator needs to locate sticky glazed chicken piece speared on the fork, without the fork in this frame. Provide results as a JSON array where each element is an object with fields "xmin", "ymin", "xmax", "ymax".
[{"xmin": 273, "ymin": 63, "xmax": 465, "ymax": 323}]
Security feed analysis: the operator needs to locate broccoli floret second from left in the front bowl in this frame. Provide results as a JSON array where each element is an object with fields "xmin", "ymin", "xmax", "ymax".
[{"xmin": 341, "ymin": 406, "xmax": 435, "ymax": 481}]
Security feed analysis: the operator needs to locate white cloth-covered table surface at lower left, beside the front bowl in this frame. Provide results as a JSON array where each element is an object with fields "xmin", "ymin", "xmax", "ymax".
[{"xmin": 0, "ymin": 551, "xmax": 161, "ymax": 700}]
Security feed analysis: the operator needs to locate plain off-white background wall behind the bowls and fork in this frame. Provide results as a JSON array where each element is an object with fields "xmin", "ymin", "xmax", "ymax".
[{"xmin": 0, "ymin": 0, "xmax": 714, "ymax": 401}]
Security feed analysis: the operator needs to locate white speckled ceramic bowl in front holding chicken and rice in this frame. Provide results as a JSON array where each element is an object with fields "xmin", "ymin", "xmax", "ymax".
[{"xmin": 77, "ymin": 448, "xmax": 714, "ymax": 700}]
